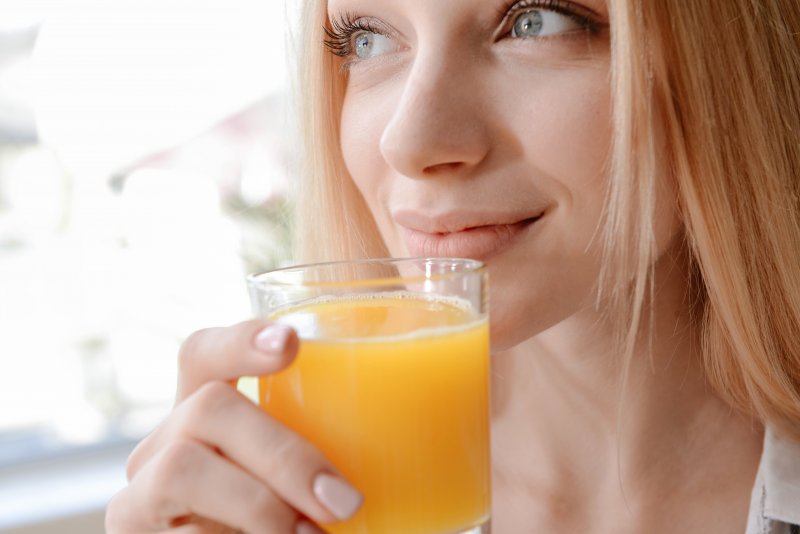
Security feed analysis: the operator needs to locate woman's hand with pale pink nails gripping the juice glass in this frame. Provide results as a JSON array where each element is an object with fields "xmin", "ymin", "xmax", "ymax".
[{"xmin": 106, "ymin": 320, "xmax": 361, "ymax": 534}]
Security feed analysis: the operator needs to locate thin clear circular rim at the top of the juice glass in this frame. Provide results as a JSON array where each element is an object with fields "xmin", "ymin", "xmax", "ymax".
[{"xmin": 246, "ymin": 256, "xmax": 488, "ymax": 288}]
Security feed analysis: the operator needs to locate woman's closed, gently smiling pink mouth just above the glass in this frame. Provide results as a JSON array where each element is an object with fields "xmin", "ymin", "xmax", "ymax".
[{"xmin": 403, "ymin": 215, "xmax": 542, "ymax": 260}]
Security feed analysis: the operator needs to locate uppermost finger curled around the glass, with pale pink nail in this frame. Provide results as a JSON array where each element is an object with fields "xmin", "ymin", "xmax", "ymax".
[{"xmin": 175, "ymin": 319, "xmax": 299, "ymax": 404}]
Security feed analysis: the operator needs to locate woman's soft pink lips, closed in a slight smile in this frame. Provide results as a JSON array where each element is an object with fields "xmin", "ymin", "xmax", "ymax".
[{"xmin": 396, "ymin": 215, "xmax": 541, "ymax": 260}]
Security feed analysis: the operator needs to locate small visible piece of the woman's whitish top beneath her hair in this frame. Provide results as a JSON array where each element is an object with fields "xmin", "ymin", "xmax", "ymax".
[{"xmin": 745, "ymin": 428, "xmax": 800, "ymax": 534}]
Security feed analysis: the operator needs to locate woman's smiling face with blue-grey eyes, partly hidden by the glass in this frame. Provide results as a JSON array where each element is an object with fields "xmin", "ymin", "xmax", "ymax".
[{"xmin": 328, "ymin": 0, "xmax": 664, "ymax": 348}]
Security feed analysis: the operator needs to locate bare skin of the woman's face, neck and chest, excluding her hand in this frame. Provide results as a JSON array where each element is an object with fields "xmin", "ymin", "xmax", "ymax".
[{"xmin": 328, "ymin": 0, "xmax": 763, "ymax": 533}]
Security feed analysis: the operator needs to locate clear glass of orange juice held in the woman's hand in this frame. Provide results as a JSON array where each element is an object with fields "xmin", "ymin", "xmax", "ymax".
[{"xmin": 248, "ymin": 258, "xmax": 491, "ymax": 534}]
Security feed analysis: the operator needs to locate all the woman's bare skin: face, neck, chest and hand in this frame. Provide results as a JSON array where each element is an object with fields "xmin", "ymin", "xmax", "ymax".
[{"xmin": 107, "ymin": 0, "xmax": 763, "ymax": 534}]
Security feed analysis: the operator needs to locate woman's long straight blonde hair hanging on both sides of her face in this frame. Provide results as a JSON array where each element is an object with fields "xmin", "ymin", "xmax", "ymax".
[{"xmin": 298, "ymin": 0, "xmax": 800, "ymax": 440}]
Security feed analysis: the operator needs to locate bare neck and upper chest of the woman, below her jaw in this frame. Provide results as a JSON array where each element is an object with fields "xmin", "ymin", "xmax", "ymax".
[{"xmin": 492, "ymin": 245, "xmax": 763, "ymax": 533}]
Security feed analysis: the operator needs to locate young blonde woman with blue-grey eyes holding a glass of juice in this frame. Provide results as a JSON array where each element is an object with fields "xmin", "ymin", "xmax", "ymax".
[{"xmin": 107, "ymin": 0, "xmax": 800, "ymax": 534}]
